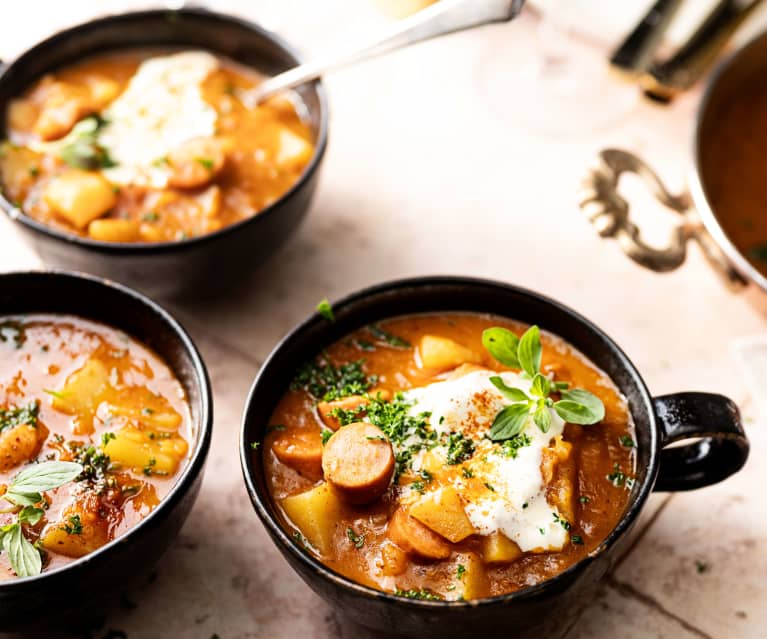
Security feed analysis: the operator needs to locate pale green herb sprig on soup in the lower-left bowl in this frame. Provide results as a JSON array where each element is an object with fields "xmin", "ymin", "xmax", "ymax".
[{"xmin": 0, "ymin": 461, "xmax": 83, "ymax": 577}]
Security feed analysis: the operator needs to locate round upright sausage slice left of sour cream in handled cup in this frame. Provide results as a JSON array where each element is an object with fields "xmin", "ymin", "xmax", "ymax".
[{"xmin": 322, "ymin": 422, "xmax": 394, "ymax": 504}]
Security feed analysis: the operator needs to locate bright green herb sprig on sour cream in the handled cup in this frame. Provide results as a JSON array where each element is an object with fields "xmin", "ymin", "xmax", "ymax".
[{"xmin": 482, "ymin": 326, "xmax": 605, "ymax": 441}]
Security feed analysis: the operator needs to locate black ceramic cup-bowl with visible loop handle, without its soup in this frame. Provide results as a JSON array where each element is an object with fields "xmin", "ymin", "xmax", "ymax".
[{"xmin": 240, "ymin": 277, "xmax": 749, "ymax": 639}]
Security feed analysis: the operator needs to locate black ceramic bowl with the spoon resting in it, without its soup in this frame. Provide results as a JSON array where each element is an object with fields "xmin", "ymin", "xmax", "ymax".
[{"xmin": 0, "ymin": 8, "xmax": 328, "ymax": 296}]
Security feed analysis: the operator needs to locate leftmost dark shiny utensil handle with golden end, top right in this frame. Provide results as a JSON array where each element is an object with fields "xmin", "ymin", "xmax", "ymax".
[{"xmin": 610, "ymin": 0, "xmax": 684, "ymax": 79}]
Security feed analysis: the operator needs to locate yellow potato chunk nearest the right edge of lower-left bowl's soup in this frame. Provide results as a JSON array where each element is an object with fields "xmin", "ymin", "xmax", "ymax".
[{"xmin": 104, "ymin": 426, "xmax": 189, "ymax": 477}]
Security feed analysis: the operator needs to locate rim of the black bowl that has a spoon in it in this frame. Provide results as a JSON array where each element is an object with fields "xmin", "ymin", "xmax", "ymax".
[{"xmin": 0, "ymin": 7, "xmax": 329, "ymax": 255}]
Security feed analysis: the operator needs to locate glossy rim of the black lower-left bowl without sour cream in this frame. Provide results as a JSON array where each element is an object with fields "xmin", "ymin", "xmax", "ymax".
[{"xmin": 0, "ymin": 269, "xmax": 213, "ymax": 591}]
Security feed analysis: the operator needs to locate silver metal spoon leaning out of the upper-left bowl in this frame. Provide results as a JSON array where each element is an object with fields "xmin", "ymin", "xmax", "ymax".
[{"xmin": 239, "ymin": 0, "xmax": 524, "ymax": 108}]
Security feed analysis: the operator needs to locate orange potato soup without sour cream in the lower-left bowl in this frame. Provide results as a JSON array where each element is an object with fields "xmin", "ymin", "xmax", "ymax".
[{"xmin": 0, "ymin": 315, "xmax": 191, "ymax": 581}]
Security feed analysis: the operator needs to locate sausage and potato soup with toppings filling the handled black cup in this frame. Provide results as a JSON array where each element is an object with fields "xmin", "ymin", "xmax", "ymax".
[{"xmin": 260, "ymin": 309, "xmax": 635, "ymax": 600}]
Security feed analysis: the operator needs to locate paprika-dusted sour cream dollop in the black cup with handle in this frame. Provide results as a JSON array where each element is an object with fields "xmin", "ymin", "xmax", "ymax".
[{"xmin": 405, "ymin": 370, "xmax": 568, "ymax": 552}]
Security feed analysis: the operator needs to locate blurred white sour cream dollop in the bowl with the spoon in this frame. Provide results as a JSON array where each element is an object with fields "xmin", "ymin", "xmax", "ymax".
[{"xmin": 99, "ymin": 51, "xmax": 219, "ymax": 188}]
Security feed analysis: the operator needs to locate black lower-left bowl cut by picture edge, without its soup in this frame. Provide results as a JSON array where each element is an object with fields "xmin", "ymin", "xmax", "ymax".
[{"xmin": 0, "ymin": 272, "xmax": 213, "ymax": 633}]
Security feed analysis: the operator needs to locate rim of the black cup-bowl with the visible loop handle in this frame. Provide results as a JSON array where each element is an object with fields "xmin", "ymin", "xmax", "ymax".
[{"xmin": 240, "ymin": 276, "xmax": 659, "ymax": 609}]
